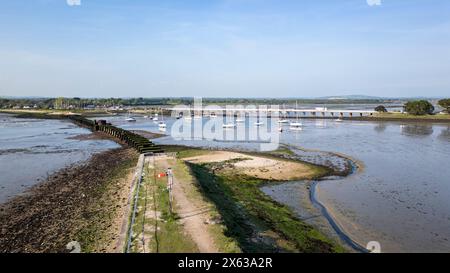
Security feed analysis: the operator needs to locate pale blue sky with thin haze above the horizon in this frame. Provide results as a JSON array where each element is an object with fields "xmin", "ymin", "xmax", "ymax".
[{"xmin": 0, "ymin": 0, "xmax": 450, "ymax": 97}]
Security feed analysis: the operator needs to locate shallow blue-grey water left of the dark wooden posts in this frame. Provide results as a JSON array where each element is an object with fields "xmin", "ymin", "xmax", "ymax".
[{"xmin": 0, "ymin": 114, "xmax": 118, "ymax": 203}]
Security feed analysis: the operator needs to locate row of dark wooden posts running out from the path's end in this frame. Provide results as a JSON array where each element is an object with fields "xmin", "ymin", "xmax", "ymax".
[{"xmin": 69, "ymin": 116, "xmax": 164, "ymax": 154}]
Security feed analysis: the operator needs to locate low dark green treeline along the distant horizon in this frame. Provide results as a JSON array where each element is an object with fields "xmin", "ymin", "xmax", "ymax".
[{"xmin": 0, "ymin": 97, "xmax": 395, "ymax": 109}]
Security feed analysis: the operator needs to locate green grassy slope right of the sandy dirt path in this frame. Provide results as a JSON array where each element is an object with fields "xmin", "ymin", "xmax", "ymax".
[{"xmin": 189, "ymin": 163, "xmax": 344, "ymax": 253}]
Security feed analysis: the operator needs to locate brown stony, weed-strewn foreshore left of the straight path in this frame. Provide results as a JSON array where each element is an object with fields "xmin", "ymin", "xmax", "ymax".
[{"xmin": 0, "ymin": 147, "xmax": 137, "ymax": 253}]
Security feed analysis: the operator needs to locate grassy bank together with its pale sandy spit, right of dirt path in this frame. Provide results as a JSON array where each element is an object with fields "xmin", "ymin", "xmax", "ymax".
[{"xmin": 171, "ymin": 147, "xmax": 351, "ymax": 253}]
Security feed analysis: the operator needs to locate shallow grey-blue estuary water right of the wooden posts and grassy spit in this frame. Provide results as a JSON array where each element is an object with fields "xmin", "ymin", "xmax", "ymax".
[{"xmin": 102, "ymin": 113, "xmax": 450, "ymax": 252}]
